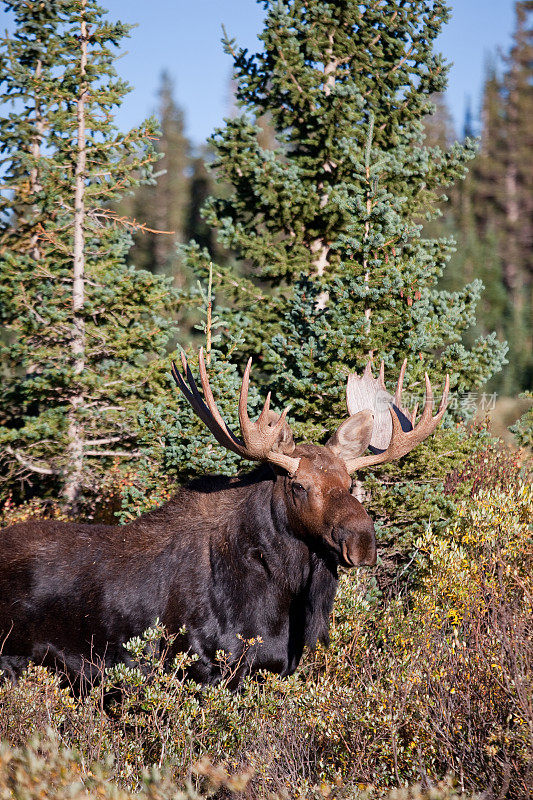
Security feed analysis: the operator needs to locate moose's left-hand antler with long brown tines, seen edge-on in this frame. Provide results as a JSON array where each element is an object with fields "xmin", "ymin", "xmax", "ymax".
[{"xmin": 172, "ymin": 348, "xmax": 300, "ymax": 475}]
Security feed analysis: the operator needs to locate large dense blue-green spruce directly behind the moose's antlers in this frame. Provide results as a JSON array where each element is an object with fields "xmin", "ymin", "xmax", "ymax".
[{"xmin": 186, "ymin": 0, "xmax": 505, "ymax": 437}]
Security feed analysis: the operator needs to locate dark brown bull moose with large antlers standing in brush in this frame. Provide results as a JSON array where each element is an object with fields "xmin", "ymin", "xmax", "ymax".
[{"xmin": 0, "ymin": 351, "xmax": 449, "ymax": 683}]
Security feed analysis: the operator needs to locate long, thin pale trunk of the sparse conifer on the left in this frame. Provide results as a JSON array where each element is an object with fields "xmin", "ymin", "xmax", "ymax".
[{"xmin": 64, "ymin": 0, "xmax": 87, "ymax": 514}]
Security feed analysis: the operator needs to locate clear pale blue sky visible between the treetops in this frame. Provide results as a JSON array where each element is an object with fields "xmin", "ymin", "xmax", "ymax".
[{"xmin": 0, "ymin": 0, "xmax": 514, "ymax": 143}]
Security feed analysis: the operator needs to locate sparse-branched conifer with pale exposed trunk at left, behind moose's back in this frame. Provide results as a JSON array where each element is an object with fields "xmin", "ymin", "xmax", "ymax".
[{"xmin": 0, "ymin": 0, "xmax": 176, "ymax": 513}]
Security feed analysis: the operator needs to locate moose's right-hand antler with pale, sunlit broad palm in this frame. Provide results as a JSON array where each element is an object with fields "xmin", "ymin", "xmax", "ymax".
[{"xmin": 346, "ymin": 359, "xmax": 450, "ymax": 472}]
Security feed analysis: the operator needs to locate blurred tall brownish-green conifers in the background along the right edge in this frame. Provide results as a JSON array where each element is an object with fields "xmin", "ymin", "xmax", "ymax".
[{"xmin": 450, "ymin": 0, "xmax": 533, "ymax": 394}]
